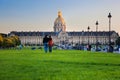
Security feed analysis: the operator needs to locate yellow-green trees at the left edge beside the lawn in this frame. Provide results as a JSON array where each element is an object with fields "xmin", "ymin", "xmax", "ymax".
[{"xmin": 0, "ymin": 34, "xmax": 21, "ymax": 48}]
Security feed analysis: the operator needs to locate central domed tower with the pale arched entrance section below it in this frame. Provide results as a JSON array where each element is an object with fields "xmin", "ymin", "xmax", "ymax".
[{"xmin": 53, "ymin": 11, "xmax": 69, "ymax": 44}]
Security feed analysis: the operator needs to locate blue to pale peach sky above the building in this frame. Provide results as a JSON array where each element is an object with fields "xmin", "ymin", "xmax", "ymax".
[{"xmin": 0, "ymin": 0, "xmax": 120, "ymax": 34}]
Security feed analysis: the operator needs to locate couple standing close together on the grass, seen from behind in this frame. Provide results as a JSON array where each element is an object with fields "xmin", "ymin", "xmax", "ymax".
[{"xmin": 43, "ymin": 35, "xmax": 53, "ymax": 53}]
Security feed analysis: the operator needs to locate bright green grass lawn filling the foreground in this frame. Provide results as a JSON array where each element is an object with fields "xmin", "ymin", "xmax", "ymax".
[{"xmin": 0, "ymin": 49, "xmax": 120, "ymax": 80}]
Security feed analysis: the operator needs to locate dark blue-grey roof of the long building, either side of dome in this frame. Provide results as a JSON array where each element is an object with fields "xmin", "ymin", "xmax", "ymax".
[{"xmin": 10, "ymin": 31, "xmax": 119, "ymax": 36}]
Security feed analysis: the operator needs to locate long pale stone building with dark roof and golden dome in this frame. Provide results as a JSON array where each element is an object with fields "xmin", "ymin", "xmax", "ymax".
[{"xmin": 10, "ymin": 11, "xmax": 119, "ymax": 45}]
